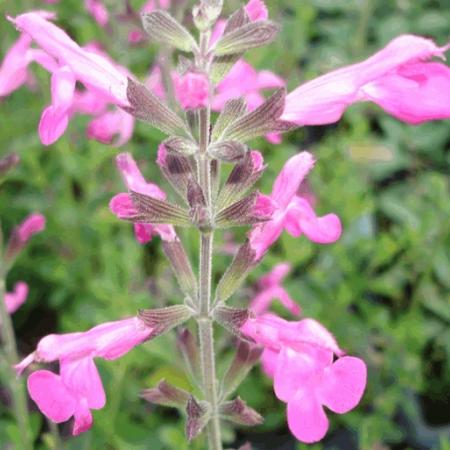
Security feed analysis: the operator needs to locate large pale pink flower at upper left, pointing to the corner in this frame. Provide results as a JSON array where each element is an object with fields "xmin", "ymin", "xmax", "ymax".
[{"xmin": 9, "ymin": 12, "xmax": 134, "ymax": 145}]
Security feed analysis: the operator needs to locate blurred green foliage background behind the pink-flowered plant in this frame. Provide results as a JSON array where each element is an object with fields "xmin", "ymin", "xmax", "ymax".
[{"xmin": 0, "ymin": 0, "xmax": 450, "ymax": 450}]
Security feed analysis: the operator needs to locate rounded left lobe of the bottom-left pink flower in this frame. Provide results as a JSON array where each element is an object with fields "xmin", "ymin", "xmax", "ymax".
[{"xmin": 27, "ymin": 370, "xmax": 76, "ymax": 423}]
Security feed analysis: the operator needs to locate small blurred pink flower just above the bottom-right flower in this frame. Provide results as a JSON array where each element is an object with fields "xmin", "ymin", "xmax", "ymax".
[{"xmin": 250, "ymin": 263, "xmax": 300, "ymax": 315}]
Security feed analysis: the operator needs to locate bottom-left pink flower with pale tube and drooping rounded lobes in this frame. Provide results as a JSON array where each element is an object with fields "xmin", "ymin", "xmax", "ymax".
[{"xmin": 16, "ymin": 317, "xmax": 153, "ymax": 435}]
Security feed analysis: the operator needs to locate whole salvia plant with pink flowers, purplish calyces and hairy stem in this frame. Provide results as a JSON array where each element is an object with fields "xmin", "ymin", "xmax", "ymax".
[{"xmin": 0, "ymin": 0, "xmax": 450, "ymax": 450}]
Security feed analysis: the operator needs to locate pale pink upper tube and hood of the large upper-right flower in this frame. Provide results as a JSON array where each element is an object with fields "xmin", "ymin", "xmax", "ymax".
[{"xmin": 281, "ymin": 35, "xmax": 448, "ymax": 125}]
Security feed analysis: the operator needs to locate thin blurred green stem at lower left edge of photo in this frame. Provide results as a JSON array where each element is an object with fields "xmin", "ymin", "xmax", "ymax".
[{"xmin": 0, "ymin": 268, "xmax": 33, "ymax": 450}]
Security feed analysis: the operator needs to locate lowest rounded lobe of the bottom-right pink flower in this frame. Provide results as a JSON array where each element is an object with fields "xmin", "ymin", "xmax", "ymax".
[{"xmin": 287, "ymin": 391, "xmax": 329, "ymax": 444}]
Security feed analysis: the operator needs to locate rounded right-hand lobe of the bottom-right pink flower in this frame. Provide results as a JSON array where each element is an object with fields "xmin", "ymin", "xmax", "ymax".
[{"xmin": 319, "ymin": 356, "xmax": 367, "ymax": 414}]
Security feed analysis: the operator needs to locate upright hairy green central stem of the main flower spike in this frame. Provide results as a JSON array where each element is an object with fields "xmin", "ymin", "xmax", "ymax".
[{"xmin": 197, "ymin": 27, "xmax": 222, "ymax": 450}]
